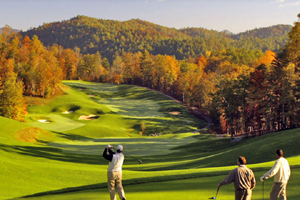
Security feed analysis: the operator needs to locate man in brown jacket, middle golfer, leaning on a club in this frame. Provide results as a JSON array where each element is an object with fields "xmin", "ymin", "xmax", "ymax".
[{"xmin": 218, "ymin": 156, "xmax": 256, "ymax": 200}]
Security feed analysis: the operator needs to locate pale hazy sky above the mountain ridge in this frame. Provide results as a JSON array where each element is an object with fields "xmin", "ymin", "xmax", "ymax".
[{"xmin": 0, "ymin": 0, "xmax": 300, "ymax": 33}]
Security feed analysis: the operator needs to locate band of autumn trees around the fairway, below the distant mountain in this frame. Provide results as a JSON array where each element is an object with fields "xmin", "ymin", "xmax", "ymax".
[{"xmin": 0, "ymin": 13, "xmax": 300, "ymax": 135}]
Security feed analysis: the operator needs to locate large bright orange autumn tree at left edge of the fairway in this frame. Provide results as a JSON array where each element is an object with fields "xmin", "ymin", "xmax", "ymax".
[{"xmin": 15, "ymin": 36, "xmax": 62, "ymax": 97}]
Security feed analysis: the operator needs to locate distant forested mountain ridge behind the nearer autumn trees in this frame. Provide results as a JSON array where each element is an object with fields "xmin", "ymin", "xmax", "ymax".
[{"xmin": 21, "ymin": 16, "xmax": 291, "ymax": 61}]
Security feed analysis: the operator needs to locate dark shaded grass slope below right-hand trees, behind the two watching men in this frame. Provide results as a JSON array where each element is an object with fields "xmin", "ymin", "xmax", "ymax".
[{"xmin": 129, "ymin": 130, "xmax": 300, "ymax": 171}]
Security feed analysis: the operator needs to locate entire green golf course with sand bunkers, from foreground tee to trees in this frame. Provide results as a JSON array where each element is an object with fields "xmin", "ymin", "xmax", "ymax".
[{"xmin": 0, "ymin": 81, "xmax": 300, "ymax": 200}]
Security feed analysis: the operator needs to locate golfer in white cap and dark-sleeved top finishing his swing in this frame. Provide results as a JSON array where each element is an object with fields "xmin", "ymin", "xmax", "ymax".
[{"xmin": 103, "ymin": 145, "xmax": 126, "ymax": 200}]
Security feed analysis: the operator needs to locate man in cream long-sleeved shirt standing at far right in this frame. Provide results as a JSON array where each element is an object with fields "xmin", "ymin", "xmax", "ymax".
[{"xmin": 260, "ymin": 149, "xmax": 291, "ymax": 200}]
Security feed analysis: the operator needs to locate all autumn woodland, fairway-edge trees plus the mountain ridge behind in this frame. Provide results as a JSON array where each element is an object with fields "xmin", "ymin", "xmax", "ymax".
[{"xmin": 0, "ymin": 14, "xmax": 300, "ymax": 135}]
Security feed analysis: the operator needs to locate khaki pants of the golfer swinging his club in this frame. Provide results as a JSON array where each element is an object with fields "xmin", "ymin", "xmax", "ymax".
[{"xmin": 107, "ymin": 171, "xmax": 125, "ymax": 200}]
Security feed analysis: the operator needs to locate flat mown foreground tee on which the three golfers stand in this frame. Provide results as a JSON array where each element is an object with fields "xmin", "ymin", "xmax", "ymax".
[{"xmin": 14, "ymin": 169, "xmax": 300, "ymax": 200}]
